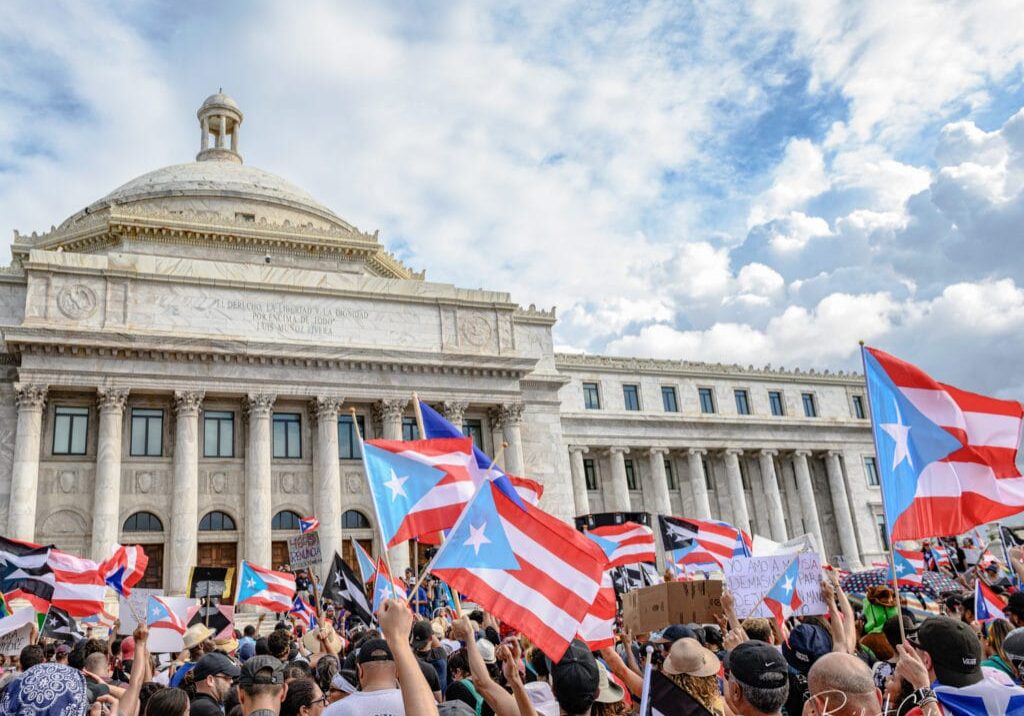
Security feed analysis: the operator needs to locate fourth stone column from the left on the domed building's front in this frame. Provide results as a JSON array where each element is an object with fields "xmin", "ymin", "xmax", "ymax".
[{"xmin": 242, "ymin": 393, "xmax": 272, "ymax": 585}]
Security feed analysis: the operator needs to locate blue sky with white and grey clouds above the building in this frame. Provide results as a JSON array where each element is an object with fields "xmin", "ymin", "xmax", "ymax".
[{"xmin": 6, "ymin": 0, "xmax": 1024, "ymax": 397}]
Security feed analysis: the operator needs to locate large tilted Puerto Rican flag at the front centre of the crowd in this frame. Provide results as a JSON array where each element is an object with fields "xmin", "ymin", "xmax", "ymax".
[{"xmin": 430, "ymin": 481, "xmax": 607, "ymax": 662}]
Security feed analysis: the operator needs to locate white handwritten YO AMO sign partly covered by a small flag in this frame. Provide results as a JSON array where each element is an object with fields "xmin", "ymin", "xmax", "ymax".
[{"xmin": 725, "ymin": 552, "xmax": 827, "ymax": 620}]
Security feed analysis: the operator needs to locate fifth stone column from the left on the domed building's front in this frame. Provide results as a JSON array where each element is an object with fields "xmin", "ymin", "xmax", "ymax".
[{"xmin": 309, "ymin": 395, "xmax": 344, "ymax": 578}]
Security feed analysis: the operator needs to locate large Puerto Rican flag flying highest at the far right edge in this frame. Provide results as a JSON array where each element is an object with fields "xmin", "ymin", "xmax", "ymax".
[{"xmin": 863, "ymin": 347, "xmax": 1024, "ymax": 540}]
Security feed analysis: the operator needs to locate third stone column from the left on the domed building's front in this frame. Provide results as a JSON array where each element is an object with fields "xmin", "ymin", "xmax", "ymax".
[{"xmin": 168, "ymin": 390, "xmax": 204, "ymax": 595}]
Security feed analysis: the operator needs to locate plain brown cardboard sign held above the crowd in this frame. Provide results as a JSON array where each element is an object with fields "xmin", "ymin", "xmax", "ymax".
[{"xmin": 623, "ymin": 580, "xmax": 722, "ymax": 634}]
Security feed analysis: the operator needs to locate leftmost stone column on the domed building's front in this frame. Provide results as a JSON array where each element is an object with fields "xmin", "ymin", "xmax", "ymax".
[{"xmin": 7, "ymin": 383, "xmax": 46, "ymax": 542}]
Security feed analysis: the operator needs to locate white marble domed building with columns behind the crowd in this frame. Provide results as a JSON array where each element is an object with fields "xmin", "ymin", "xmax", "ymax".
[{"xmin": 0, "ymin": 94, "xmax": 881, "ymax": 593}]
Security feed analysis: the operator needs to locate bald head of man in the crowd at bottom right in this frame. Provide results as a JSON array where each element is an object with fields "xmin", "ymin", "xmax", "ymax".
[{"xmin": 804, "ymin": 652, "xmax": 882, "ymax": 716}]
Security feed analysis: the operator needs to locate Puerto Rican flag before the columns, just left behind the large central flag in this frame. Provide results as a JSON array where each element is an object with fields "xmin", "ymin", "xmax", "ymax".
[{"xmin": 362, "ymin": 437, "xmax": 475, "ymax": 547}]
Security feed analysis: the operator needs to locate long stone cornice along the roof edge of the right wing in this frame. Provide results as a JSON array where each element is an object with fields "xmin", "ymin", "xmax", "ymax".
[{"xmin": 555, "ymin": 353, "xmax": 864, "ymax": 386}]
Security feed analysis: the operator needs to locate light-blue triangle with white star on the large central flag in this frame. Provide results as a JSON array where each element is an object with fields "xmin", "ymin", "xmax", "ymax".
[{"xmin": 434, "ymin": 482, "xmax": 520, "ymax": 570}]
